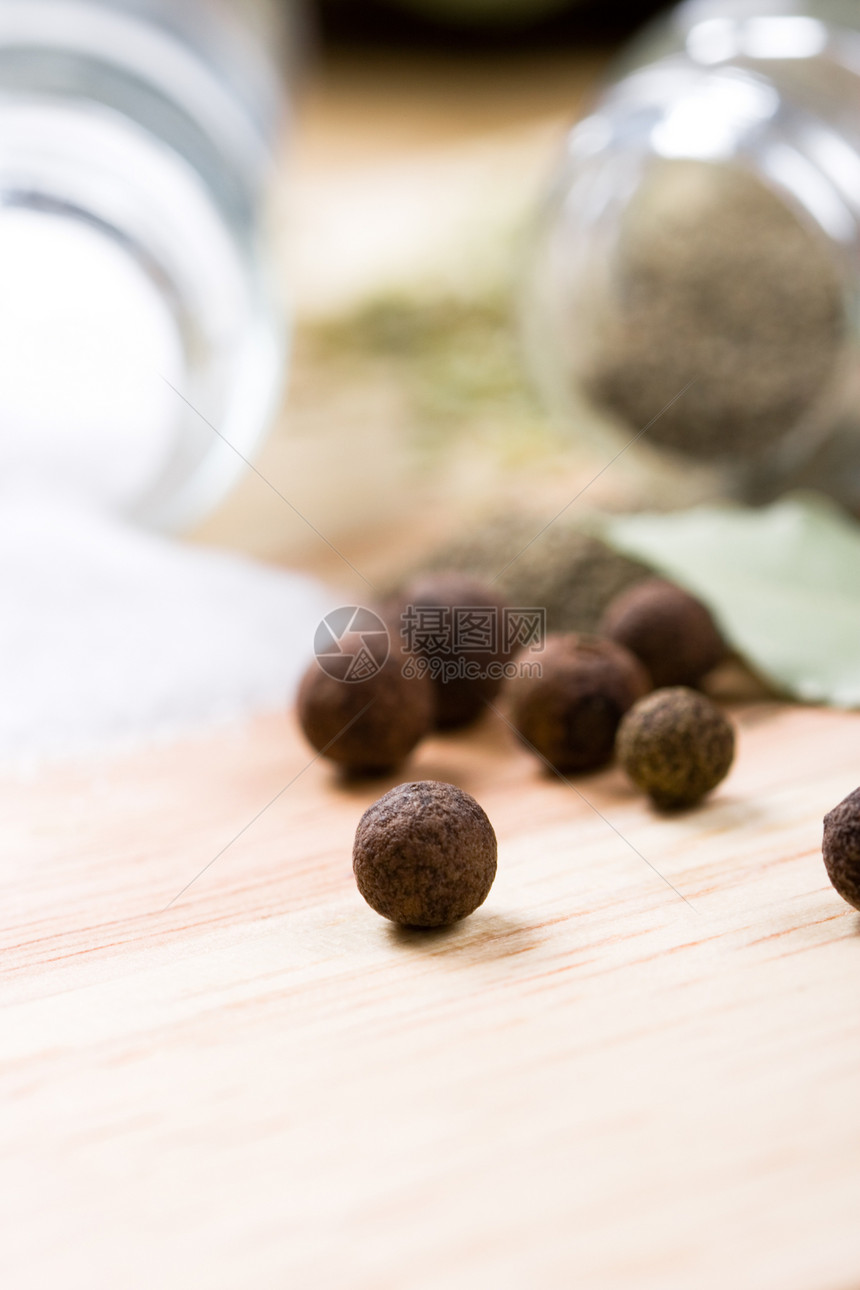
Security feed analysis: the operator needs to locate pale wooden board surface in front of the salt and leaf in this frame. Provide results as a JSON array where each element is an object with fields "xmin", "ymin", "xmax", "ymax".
[{"xmin": 0, "ymin": 704, "xmax": 860, "ymax": 1290}]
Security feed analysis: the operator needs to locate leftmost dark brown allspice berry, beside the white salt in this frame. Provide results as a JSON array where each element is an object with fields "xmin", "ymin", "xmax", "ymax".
[{"xmin": 297, "ymin": 650, "xmax": 435, "ymax": 774}]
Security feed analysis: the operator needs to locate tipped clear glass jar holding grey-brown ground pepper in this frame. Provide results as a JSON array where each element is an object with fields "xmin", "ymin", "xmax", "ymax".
[{"xmin": 526, "ymin": 0, "xmax": 860, "ymax": 510}]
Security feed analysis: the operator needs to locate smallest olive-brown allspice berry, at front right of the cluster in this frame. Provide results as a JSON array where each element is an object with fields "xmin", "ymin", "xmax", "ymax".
[{"xmin": 618, "ymin": 685, "xmax": 735, "ymax": 810}]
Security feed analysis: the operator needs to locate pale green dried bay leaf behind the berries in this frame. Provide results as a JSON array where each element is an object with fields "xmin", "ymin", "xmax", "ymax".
[{"xmin": 601, "ymin": 493, "xmax": 860, "ymax": 708}]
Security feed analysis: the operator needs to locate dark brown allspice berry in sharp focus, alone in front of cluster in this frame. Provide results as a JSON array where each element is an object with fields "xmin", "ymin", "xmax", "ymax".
[{"xmin": 352, "ymin": 779, "xmax": 496, "ymax": 928}]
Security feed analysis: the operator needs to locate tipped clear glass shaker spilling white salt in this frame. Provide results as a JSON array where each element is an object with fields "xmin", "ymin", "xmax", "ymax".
[{"xmin": 0, "ymin": 0, "xmax": 288, "ymax": 529}]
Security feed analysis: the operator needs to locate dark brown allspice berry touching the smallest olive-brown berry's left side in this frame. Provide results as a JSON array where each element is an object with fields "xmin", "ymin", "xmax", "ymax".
[{"xmin": 511, "ymin": 632, "xmax": 651, "ymax": 773}]
